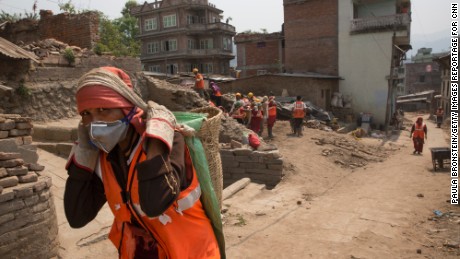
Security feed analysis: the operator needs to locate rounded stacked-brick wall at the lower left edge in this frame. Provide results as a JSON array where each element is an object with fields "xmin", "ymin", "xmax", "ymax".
[{"xmin": 0, "ymin": 114, "xmax": 59, "ymax": 259}]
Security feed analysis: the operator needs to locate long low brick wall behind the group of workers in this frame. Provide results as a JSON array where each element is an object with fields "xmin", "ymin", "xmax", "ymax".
[{"xmin": 219, "ymin": 75, "xmax": 339, "ymax": 109}]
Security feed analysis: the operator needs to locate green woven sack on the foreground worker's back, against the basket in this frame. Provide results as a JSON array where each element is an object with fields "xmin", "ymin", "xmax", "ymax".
[{"xmin": 173, "ymin": 112, "xmax": 226, "ymax": 259}]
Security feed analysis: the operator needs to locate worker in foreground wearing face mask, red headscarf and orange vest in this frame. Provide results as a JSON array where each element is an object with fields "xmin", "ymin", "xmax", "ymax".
[{"xmin": 64, "ymin": 67, "xmax": 225, "ymax": 259}]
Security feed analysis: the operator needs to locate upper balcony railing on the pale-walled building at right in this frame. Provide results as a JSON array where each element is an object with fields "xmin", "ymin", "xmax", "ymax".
[{"xmin": 351, "ymin": 13, "xmax": 411, "ymax": 33}]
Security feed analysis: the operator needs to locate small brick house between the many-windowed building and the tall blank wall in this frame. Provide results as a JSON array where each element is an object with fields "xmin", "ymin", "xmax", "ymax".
[{"xmin": 235, "ymin": 33, "xmax": 284, "ymax": 77}]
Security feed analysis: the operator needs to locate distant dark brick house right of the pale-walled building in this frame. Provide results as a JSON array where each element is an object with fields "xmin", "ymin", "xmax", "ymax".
[{"xmin": 405, "ymin": 62, "xmax": 442, "ymax": 94}]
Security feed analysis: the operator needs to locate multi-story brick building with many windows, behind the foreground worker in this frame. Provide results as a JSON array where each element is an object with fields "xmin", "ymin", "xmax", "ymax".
[{"xmin": 131, "ymin": 0, "xmax": 236, "ymax": 74}]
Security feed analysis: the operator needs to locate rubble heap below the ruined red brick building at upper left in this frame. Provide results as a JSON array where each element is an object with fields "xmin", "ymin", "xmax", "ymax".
[{"xmin": 19, "ymin": 39, "xmax": 89, "ymax": 58}]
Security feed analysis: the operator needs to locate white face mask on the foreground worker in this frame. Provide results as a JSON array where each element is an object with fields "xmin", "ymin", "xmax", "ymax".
[{"xmin": 89, "ymin": 107, "xmax": 136, "ymax": 153}]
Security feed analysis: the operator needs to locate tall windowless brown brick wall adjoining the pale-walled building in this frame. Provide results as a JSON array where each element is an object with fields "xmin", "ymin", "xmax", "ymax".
[{"xmin": 284, "ymin": 0, "xmax": 338, "ymax": 75}]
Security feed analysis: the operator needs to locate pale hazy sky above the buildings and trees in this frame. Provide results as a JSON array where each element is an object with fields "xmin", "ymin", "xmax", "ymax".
[{"xmin": 0, "ymin": 0, "xmax": 460, "ymax": 51}]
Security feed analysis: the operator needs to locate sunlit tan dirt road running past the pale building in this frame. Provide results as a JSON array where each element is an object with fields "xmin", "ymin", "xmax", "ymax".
[{"xmin": 224, "ymin": 114, "xmax": 460, "ymax": 258}]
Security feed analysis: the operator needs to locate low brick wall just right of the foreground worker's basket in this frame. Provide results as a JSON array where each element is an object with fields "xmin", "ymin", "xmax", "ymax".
[{"xmin": 220, "ymin": 147, "xmax": 283, "ymax": 188}]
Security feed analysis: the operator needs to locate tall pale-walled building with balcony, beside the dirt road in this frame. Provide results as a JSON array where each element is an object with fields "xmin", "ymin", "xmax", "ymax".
[{"xmin": 340, "ymin": 0, "xmax": 411, "ymax": 126}]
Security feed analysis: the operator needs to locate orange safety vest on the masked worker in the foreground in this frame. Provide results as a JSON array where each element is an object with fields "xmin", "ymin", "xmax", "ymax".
[{"xmin": 99, "ymin": 141, "xmax": 220, "ymax": 259}]
